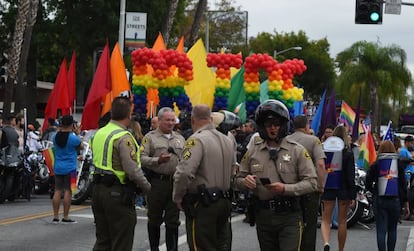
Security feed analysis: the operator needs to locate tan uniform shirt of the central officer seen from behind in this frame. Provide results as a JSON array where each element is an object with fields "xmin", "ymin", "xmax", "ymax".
[{"xmin": 173, "ymin": 125, "xmax": 236, "ymax": 202}]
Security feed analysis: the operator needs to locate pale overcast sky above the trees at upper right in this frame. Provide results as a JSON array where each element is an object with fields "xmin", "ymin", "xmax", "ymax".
[{"xmin": 235, "ymin": 0, "xmax": 414, "ymax": 76}]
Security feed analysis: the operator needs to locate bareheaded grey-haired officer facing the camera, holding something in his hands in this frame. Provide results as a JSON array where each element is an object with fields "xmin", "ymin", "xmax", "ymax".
[{"xmin": 141, "ymin": 107, "xmax": 185, "ymax": 251}]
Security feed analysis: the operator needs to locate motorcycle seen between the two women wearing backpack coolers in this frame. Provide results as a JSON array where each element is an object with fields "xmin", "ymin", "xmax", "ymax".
[{"xmin": 346, "ymin": 168, "xmax": 374, "ymax": 228}]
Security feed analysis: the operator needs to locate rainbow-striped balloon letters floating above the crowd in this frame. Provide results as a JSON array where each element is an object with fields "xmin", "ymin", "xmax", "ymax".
[{"xmin": 132, "ymin": 48, "xmax": 306, "ymax": 116}]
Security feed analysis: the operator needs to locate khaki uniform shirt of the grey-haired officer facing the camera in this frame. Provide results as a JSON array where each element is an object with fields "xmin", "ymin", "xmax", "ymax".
[{"xmin": 140, "ymin": 129, "xmax": 185, "ymax": 175}]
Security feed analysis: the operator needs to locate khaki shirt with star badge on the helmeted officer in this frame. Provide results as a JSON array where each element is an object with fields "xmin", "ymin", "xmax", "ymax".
[{"xmin": 235, "ymin": 135, "xmax": 317, "ymax": 200}]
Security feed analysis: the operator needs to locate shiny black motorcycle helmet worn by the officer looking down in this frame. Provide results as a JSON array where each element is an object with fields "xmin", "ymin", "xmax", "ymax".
[{"xmin": 255, "ymin": 99, "xmax": 290, "ymax": 143}]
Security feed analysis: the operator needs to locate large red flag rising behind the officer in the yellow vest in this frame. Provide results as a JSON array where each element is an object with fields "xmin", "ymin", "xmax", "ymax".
[{"xmin": 82, "ymin": 42, "xmax": 112, "ymax": 130}]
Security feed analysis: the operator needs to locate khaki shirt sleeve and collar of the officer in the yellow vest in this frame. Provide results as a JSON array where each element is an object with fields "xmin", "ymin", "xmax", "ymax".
[{"xmin": 111, "ymin": 120, "xmax": 151, "ymax": 193}]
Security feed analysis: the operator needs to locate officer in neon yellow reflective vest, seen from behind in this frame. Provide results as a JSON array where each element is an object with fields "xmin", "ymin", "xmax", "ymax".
[{"xmin": 92, "ymin": 97, "xmax": 151, "ymax": 251}]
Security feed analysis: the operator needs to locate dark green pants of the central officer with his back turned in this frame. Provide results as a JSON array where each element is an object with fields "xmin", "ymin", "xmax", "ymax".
[{"xmin": 185, "ymin": 199, "xmax": 232, "ymax": 251}]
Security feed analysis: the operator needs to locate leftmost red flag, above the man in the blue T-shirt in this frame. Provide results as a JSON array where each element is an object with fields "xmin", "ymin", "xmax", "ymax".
[{"xmin": 42, "ymin": 58, "xmax": 70, "ymax": 130}]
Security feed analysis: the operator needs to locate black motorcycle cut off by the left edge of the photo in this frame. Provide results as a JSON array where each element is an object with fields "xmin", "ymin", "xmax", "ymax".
[{"xmin": 0, "ymin": 146, "xmax": 32, "ymax": 203}]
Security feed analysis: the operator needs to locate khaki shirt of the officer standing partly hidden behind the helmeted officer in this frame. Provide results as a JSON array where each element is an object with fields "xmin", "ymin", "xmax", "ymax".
[{"xmin": 286, "ymin": 131, "xmax": 326, "ymax": 172}]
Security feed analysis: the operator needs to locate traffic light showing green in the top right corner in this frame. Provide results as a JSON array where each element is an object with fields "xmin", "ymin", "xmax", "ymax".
[{"xmin": 355, "ymin": 0, "xmax": 383, "ymax": 24}]
